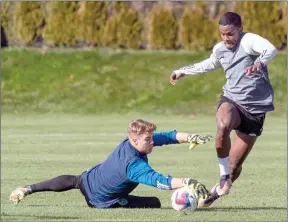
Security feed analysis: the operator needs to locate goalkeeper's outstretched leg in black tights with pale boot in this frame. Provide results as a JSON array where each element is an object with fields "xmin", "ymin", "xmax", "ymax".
[{"xmin": 9, "ymin": 175, "xmax": 81, "ymax": 204}]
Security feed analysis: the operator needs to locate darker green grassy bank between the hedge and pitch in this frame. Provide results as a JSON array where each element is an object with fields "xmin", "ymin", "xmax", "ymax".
[{"xmin": 1, "ymin": 48, "xmax": 287, "ymax": 115}]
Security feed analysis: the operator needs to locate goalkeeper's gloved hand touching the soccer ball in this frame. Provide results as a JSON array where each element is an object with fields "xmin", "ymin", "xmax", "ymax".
[{"xmin": 182, "ymin": 178, "xmax": 210, "ymax": 199}]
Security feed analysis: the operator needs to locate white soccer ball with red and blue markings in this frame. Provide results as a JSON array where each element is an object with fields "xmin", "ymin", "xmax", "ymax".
[{"xmin": 171, "ymin": 187, "xmax": 198, "ymax": 211}]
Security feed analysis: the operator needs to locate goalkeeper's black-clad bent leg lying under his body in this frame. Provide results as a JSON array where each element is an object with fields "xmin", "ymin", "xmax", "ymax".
[{"xmin": 112, "ymin": 195, "xmax": 161, "ymax": 208}]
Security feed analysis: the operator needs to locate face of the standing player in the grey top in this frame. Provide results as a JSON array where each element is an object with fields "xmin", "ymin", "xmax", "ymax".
[{"xmin": 219, "ymin": 25, "xmax": 243, "ymax": 49}]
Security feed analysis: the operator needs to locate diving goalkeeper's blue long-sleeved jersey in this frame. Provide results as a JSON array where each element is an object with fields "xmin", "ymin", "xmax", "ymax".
[{"xmin": 83, "ymin": 130, "xmax": 178, "ymax": 208}]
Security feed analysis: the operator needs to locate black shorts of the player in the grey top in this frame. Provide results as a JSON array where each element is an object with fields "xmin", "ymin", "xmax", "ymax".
[{"xmin": 217, "ymin": 96, "xmax": 266, "ymax": 136}]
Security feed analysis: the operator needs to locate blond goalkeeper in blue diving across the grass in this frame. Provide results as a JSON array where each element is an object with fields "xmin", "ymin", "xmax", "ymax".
[{"xmin": 10, "ymin": 119, "xmax": 211, "ymax": 208}]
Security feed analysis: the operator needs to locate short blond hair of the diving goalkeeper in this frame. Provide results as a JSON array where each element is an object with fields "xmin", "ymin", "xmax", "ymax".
[{"xmin": 127, "ymin": 119, "xmax": 156, "ymax": 138}]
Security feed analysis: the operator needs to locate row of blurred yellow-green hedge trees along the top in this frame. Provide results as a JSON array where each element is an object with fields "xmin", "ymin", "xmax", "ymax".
[{"xmin": 1, "ymin": 1, "xmax": 287, "ymax": 50}]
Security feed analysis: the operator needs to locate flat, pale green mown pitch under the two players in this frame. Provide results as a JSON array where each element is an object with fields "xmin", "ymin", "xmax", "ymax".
[{"xmin": 1, "ymin": 114, "xmax": 287, "ymax": 222}]
